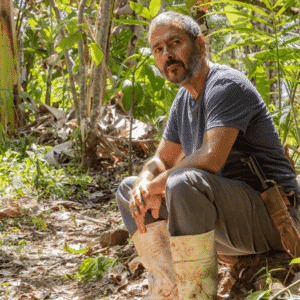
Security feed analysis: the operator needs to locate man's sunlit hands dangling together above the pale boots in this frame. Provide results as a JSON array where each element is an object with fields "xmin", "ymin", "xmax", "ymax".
[{"xmin": 129, "ymin": 180, "xmax": 162, "ymax": 233}]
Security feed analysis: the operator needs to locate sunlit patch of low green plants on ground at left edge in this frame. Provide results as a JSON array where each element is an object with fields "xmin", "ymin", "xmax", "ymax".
[{"xmin": 0, "ymin": 138, "xmax": 92, "ymax": 200}]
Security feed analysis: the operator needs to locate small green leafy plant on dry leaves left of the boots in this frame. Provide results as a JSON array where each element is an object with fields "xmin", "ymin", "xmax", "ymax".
[{"xmin": 68, "ymin": 256, "xmax": 117, "ymax": 281}]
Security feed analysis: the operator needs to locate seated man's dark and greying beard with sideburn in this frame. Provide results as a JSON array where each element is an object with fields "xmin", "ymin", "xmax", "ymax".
[{"xmin": 160, "ymin": 45, "xmax": 204, "ymax": 86}]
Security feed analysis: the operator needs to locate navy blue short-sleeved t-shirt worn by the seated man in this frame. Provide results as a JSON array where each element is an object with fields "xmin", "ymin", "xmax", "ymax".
[{"xmin": 163, "ymin": 64, "xmax": 299, "ymax": 192}]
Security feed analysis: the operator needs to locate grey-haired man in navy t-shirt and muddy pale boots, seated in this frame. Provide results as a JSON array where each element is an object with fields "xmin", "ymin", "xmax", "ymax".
[{"xmin": 117, "ymin": 12, "xmax": 299, "ymax": 300}]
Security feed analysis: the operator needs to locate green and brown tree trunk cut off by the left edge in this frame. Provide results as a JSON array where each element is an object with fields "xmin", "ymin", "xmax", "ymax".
[{"xmin": 0, "ymin": 0, "xmax": 24, "ymax": 133}]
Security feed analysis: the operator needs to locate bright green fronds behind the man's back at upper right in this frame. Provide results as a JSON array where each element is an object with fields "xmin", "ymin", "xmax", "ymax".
[{"xmin": 207, "ymin": 0, "xmax": 300, "ymax": 169}]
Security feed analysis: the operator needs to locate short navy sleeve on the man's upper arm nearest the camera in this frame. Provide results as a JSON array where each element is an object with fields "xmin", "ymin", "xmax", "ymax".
[{"xmin": 204, "ymin": 79, "xmax": 255, "ymax": 134}]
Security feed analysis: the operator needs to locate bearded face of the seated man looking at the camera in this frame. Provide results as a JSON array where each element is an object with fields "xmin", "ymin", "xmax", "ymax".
[{"xmin": 150, "ymin": 25, "xmax": 202, "ymax": 86}]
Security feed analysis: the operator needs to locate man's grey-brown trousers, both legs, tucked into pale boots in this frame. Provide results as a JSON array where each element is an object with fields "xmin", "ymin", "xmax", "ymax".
[{"xmin": 116, "ymin": 169, "xmax": 298, "ymax": 255}]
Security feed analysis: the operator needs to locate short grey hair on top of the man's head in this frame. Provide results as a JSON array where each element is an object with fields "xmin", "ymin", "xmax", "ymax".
[{"xmin": 147, "ymin": 11, "xmax": 202, "ymax": 45}]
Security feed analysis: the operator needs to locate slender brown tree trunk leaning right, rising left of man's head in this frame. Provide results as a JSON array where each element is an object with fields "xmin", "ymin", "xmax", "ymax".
[{"xmin": 81, "ymin": 0, "xmax": 112, "ymax": 169}]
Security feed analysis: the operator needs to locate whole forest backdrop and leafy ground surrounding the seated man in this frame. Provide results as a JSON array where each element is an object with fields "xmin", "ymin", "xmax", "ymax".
[{"xmin": 0, "ymin": 0, "xmax": 300, "ymax": 299}]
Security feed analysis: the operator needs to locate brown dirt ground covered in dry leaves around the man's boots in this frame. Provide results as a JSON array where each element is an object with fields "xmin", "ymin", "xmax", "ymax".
[{"xmin": 0, "ymin": 160, "xmax": 297, "ymax": 300}]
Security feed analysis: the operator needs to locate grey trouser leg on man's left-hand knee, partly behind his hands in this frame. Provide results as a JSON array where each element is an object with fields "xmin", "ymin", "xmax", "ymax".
[{"xmin": 116, "ymin": 176, "xmax": 168, "ymax": 236}]
